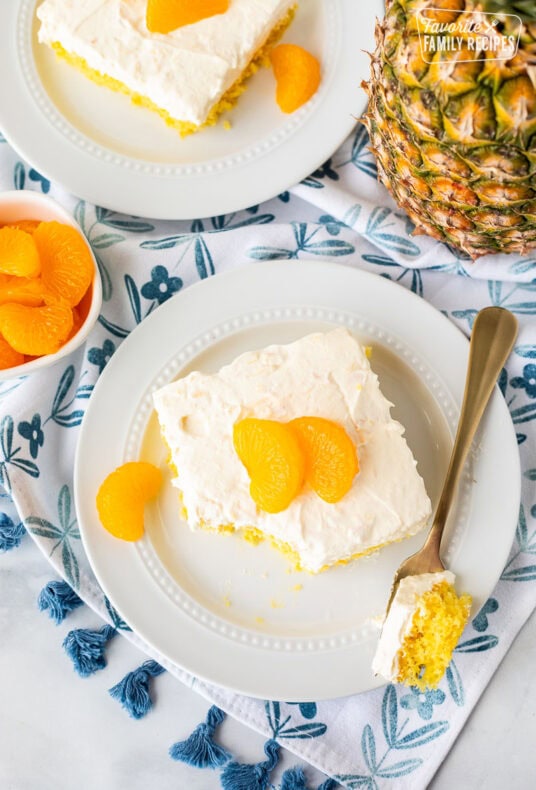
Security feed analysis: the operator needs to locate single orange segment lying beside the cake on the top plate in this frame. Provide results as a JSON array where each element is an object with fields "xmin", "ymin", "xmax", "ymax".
[{"xmin": 270, "ymin": 44, "xmax": 320, "ymax": 113}]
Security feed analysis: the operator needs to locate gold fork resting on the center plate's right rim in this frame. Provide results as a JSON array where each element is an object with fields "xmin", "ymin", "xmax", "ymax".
[{"xmin": 385, "ymin": 307, "xmax": 517, "ymax": 617}]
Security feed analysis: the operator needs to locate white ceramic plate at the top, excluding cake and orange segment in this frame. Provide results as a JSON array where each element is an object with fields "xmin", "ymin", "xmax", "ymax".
[{"xmin": 0, "ymin": 0, "xmax": 383, "ymax": 219}]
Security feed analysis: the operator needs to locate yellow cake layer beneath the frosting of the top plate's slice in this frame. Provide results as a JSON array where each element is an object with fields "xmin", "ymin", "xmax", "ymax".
[{"xmin": 52, "ymin": 6, "xmax": 297, "ymax": 137}]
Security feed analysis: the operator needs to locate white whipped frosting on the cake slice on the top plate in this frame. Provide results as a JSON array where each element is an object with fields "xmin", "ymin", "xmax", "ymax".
[{"xmin": 37, "ymin": 0, "xmax": 295, "ymax": 124}]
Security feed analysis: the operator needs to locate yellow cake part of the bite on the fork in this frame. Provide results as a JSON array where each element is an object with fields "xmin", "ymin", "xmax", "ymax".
[{"xmin": 397, "ymin": 581, "xmax": 471, "ymax": 691}]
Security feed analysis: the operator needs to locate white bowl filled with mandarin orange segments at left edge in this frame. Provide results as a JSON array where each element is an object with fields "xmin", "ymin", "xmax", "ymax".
[{"xmin": 0, "ymin": 190, "xmax": 102, "ymax": 381}]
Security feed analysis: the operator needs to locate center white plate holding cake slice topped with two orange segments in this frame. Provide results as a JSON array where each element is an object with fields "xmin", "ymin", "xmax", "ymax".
[{"xmin": 75, "ymin": 261, "xmax": 520, "ymax": 701}]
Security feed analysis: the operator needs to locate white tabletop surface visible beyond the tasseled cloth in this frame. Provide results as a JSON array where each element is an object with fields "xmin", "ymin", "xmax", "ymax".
[{"xmin": 0, "ymin": 536, "xmax": 536, "ymax": 790}]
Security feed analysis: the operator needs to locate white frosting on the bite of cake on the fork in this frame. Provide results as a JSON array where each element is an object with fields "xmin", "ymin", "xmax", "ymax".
[{"xmin": 372, "ymin": 571, "xmax": 455, "ymax": 680}]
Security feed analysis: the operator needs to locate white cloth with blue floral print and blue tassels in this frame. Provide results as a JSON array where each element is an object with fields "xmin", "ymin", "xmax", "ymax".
[{"xmin": 0, "ymin": 127, "xmax": 536, "ymax": 790}]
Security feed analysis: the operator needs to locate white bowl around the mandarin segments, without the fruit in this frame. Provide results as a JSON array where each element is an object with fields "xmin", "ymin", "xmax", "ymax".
[{"xmin": 0, "ymin": 189, "xmax": 102, "ymax": 381}]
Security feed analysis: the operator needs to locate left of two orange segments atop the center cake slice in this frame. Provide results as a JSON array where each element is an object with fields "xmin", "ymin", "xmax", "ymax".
[{"xmin": 233, "ymin": 417, "xmax": 305, "ymax": 513}]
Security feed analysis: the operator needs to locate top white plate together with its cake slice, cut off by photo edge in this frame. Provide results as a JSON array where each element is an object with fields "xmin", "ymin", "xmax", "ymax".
[{"xmin": 0, "ymin": 0, "xmax": 383, "ymax": 219}]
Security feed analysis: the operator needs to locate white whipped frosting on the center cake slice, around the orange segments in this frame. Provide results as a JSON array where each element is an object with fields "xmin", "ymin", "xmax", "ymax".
[{"xmin": 154, "ymin": 329, "xmax": 431, "ymax": 572}]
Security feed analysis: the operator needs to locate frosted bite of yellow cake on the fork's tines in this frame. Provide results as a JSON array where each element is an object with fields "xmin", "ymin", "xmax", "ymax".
[{"xmin": 372, "ymin": 571, "xmax": 471, "ymax": 691}]
